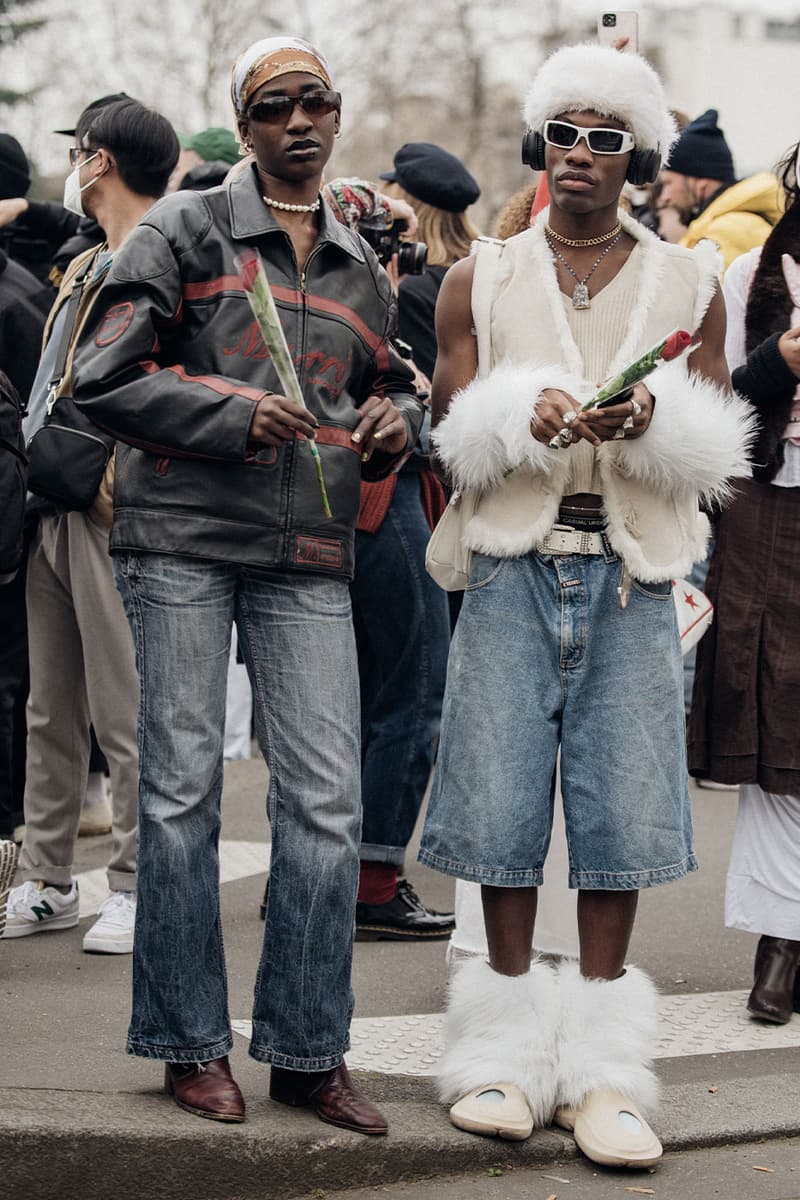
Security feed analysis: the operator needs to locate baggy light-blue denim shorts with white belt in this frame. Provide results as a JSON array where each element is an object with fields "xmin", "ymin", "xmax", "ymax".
[{"xmin": 419, "ymin": 542, "xmax": 697, "ymax": 890}]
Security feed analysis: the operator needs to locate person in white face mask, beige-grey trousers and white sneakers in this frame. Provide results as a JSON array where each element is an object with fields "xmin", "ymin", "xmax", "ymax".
[{"xmin": 4, "ymin": 98, "xmax": 179, "ymax": 954}]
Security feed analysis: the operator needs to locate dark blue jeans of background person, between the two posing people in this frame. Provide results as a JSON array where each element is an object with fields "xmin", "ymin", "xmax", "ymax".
[{"xmin": 350, "ymin": 472, "xmax": 450, "ymax": 868}]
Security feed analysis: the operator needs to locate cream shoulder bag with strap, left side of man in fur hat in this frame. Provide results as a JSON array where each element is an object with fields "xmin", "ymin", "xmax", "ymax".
[{"xmin": 425, "ymin": 238, "xmax": 504, "ymax": 592}]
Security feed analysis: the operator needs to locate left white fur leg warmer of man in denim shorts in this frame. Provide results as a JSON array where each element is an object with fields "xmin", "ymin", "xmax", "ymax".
[{"xmin": 439, "ymin": 959, "xmax": 559, "ymax": 1126}]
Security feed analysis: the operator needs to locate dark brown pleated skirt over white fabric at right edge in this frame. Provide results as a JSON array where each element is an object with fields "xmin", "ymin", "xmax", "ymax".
[{"xmin": 688, "ymin": 480, "xmax": 800, "ymax": 796}]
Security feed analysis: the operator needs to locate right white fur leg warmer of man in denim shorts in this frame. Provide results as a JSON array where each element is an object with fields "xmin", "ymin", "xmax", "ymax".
[{"xmin": 558, "ymin": 961, "xmax": 658, "ymax": 1111}]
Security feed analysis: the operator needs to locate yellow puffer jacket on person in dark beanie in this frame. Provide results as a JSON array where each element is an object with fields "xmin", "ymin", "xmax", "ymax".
[{"xmin": 680, "ymin": 172, "xmax": 783, "ymax": 270}]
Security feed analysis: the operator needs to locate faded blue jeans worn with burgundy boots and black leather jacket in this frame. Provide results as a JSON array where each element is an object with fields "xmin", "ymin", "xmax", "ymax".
[{"xmin": 115, "ymin": 553, "xmax": 361, "ymax": 1070}]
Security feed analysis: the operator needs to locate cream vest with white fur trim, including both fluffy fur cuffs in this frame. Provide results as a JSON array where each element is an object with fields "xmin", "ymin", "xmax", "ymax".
[{"xmin": 433, "ymin": 210, "xmax": 753, "ymax": 582}]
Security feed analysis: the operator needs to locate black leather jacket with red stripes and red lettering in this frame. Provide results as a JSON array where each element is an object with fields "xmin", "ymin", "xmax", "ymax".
[{"xmin": 73, "ymin": 170, "xmax": 422, "ymax": 576}]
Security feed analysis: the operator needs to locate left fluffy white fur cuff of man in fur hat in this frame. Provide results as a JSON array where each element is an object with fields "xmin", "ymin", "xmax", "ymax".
[{"xmin": 431, "ymin": 364, "xmax": 591, "ymax": 491}]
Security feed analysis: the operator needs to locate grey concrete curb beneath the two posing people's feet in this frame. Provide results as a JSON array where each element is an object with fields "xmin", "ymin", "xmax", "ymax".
[{"xmin": 6, "ymin": 1072, "xmax": 800, "ymax": 1200}]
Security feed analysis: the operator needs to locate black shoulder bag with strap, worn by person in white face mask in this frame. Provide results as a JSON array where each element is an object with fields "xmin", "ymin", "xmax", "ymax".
[{"xmin": 28, "ymin": 258, "xmax": 115, "ymax": 511}]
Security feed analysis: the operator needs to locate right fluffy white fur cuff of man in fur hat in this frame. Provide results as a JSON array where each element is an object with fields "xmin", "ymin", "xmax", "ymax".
[{"xmin": 612, "ymin": 362, "xmax": 758, "ymax": 505}]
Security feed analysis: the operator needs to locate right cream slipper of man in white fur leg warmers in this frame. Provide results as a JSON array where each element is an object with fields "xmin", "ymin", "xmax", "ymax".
[{"xmin": 554, "ymin": 1088, "xmax": 663, "ymax": 1166}]
